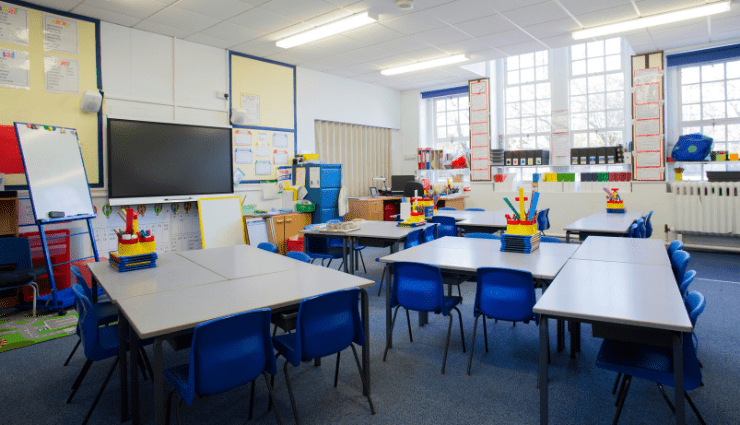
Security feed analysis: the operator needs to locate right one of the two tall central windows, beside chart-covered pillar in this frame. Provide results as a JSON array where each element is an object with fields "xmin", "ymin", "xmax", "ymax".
[{"xmin": 570, "ymin": 38, "xmax": 625, "ymax": 148}]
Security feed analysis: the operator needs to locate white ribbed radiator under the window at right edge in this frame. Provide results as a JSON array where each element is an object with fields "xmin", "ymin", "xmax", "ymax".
[{"xmin": 673, "ymin": 182, "xmax": 740, "ymax": 235}]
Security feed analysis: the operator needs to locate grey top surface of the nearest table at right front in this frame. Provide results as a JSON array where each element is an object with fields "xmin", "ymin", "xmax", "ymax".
[{"xmin": 534, "ymin": 259, "xmax": 693, "ymax": 332}]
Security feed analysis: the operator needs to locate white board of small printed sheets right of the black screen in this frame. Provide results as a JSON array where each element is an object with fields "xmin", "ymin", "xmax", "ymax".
[{"xmin": 232, "ymin": 128, "xmax": 295, "ymax": 186}]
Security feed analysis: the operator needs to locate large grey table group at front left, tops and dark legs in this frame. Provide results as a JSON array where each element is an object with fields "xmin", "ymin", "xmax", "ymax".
[{"xmin": 88, "ymin": 245, "xmax": 375, "ymax": 424}]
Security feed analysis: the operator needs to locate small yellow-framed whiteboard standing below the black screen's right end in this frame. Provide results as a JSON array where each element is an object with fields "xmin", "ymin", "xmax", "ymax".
[{"xmin": 198, "ymin": 196, "xmax": 247, "ymax": 249}]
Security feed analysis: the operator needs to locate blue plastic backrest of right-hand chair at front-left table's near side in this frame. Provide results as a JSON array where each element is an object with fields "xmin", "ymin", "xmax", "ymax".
[{"xmin": 294, "ymin": 288, "xmax": 365, "ymax": 366}]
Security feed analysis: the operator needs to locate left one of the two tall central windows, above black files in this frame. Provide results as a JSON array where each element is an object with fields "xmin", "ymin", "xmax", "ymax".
[{"xmin": 504, "ymin": 51, "xmax": 551, "ymax": 150}]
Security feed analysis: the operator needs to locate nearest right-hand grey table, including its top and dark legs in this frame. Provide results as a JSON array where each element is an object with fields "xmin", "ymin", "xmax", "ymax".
[{"xmin": 534, "ymin": 258, "xmax": 693, "ymax": 425}]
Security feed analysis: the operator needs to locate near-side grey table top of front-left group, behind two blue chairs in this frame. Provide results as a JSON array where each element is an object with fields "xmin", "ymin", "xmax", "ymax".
[{"xmin": 119, "ymin": 263, "xmax": 375, "ymax": 338}]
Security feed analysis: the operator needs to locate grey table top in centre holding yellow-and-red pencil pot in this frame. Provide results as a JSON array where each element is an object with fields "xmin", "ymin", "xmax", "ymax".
[{"xmin": 380, "ymin": 237, "xmax": 577, "ymax": 280}]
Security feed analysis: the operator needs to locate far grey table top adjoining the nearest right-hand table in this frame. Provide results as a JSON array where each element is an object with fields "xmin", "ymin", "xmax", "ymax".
[{"xmin": 571, "ymin": 236, "xmax": 671, "ymax": 267}]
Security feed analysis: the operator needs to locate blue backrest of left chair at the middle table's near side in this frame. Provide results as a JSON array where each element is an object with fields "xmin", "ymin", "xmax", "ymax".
[{"xmin": 391, "ymin": 261, "xmax": 444, "ymax": 312}]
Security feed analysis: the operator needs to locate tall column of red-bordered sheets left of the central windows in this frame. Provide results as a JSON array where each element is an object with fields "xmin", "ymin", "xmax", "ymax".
[{"xmin": 468, "ymin": 78, "xmax": 491, "ymax": 181}]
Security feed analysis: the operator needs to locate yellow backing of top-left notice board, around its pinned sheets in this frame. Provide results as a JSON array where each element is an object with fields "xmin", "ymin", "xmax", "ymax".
[{"xmin": 0, "ymin": 4, "xmax": 101, "ymax": 185}]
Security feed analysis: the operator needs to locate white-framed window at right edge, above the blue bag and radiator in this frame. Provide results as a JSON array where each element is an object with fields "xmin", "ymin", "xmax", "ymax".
[{"xmin": 678, "ymin": 59, "xmax": 740, "ymax": 153}]
